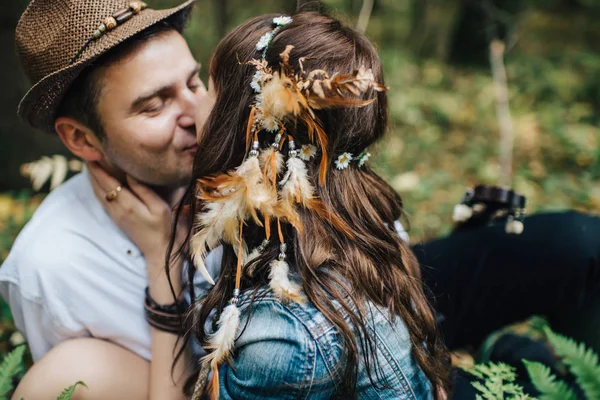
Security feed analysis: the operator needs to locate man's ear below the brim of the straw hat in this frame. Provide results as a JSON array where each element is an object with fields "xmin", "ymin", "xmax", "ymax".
[{"xmin": 54, "ymin": 117, "xmax": 104, "ymax": 161}]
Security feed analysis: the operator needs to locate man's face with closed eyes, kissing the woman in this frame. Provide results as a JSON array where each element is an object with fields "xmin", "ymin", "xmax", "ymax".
[{"xmin": 98, "ymin": 31, "xmax": 206, "ymax": 187}]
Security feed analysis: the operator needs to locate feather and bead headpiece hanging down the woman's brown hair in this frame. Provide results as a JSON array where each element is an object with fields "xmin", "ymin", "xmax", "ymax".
[{"xmin": 195, "ymin": 17, "xmax": 387, "ymax": 400}]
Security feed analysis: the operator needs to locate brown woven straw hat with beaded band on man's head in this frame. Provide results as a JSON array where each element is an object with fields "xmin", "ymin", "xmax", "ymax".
[{"xmin": 15, "ymin": 0, "xmax": 194, "ymax": 132}]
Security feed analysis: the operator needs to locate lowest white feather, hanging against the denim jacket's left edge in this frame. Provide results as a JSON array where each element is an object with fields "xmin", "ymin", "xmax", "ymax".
[{"xmin": 202, "ymin": 304, "xmax": 240, "ymax": 367}]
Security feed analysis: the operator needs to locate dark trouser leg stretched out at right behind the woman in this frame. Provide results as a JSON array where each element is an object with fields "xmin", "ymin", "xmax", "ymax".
[{"xmin": 413, "ymin": 212, "xmax": 600, "ymax": 351}]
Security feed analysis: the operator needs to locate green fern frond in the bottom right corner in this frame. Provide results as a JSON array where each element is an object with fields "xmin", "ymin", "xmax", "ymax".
[{"xmin": 544, "ymin": 328, "xmax": 600, "ymax": 399}]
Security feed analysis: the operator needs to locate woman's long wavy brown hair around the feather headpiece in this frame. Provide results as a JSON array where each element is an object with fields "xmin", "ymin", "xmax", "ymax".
[{"xmin": 183, "ymin": 8, "xmax": 447, "ymax": 398}]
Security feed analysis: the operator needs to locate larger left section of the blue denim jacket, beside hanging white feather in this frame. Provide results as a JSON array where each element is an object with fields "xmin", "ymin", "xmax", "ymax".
[{"xmin": 221, "ymin": 290, "xmax": 333, "ymax": 399}]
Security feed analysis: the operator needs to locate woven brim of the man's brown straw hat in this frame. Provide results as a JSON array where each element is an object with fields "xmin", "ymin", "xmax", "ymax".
[{"xmin": 17, "ymin": 0, "xmax": 195, "ymax": 133}]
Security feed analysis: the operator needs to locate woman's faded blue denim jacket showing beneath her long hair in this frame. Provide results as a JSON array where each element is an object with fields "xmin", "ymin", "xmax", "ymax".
[{"xmin": 219, "ymin": 292, "xmax": 433, "ymax": 400}]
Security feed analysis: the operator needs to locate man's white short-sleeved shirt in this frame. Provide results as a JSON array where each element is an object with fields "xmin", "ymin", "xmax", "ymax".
[{"xmin": 0, "ymin": 171, "xmax": 221, "ymax": 361}]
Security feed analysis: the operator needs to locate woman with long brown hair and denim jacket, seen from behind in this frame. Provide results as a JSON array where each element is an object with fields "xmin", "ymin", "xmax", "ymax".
[{"xmin": 186, "ymin": 12, "xmax": 448, "ymax": 399}]
